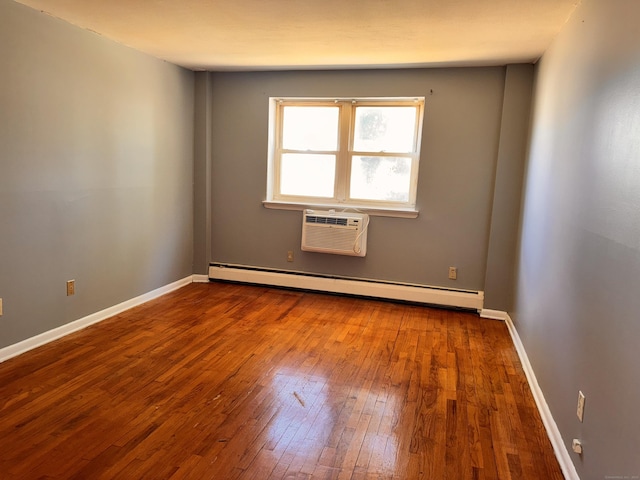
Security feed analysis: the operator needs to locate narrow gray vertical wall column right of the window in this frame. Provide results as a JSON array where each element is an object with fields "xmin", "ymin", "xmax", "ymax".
[{"xmin": 484, "ymin": 65, "xmax": 533, "ymax": 311}]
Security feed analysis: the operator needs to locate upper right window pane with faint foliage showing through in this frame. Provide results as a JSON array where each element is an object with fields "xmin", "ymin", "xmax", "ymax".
[{"xmin": 353, "ymin": 107, "xmax": 416, "ymax": 153}]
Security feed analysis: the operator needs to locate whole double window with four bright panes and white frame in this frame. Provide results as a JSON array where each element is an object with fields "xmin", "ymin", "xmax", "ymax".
[{"xmin": 266, "ymin": 98, "xmax": 424, "ymax": 214}]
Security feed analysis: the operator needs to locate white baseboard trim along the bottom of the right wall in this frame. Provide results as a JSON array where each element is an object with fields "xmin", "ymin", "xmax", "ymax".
[{"xmin": 504, "ymin": 312, "xmax": 580, "ymax": 480}]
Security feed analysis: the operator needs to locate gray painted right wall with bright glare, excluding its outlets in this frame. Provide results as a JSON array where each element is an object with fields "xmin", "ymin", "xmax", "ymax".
[{"xmin": 512, "ymin": 0, "xmax": 640, "ymax": 480}]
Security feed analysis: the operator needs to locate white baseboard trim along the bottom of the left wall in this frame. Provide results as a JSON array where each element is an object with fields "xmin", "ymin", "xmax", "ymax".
[{"xmin": 0, "ymin": 276, "xmax": 194, "ymax": 363}]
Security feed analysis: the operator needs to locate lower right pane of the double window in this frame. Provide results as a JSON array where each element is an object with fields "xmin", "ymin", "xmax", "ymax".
[{"xmin": 350, "ymin": 156, "xmax": 411, "ymax": 202}]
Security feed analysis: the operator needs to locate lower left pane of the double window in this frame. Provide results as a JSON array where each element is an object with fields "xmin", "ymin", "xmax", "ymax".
[{"xmin": 280, "ymin": 153, "xmax": 336, "ymax": 198}]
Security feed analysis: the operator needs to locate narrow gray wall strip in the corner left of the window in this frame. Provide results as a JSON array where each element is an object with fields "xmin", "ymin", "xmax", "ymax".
[{"xmin": 193, "ymin": 72, "xmax": 213, "ymax": 275}]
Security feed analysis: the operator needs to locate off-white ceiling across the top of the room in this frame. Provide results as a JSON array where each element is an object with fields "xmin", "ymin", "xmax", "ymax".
[{"xmin": 13, "ymin": 0, "xmax": 579, "ymax": 70}]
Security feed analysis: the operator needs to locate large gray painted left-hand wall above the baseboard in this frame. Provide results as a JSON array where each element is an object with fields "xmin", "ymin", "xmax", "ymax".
[{"xmin": 0, "ymin": 0, "xmax": 194, "ymax": 347}]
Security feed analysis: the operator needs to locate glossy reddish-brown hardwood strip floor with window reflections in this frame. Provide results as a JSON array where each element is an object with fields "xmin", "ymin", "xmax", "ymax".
[{"xmin": 0, "ymin": 283, "xmax": 563, "ymax": 480}]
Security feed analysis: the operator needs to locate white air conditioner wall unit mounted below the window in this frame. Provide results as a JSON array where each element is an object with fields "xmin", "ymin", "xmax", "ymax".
[{"xmin": 301, "ymin": 210, "xmax": 369, "ymax": 257}]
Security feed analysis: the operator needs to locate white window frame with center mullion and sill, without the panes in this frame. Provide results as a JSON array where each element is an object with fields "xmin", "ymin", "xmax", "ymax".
[{"xmin": 263, "ymin": 97, "xmax": 424, "ymax": 217}]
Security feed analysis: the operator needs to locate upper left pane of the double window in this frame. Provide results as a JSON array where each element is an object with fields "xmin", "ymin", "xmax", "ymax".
[{"xmin": 282, "ymin": 107, "xmax": 340, "ymax": 151}]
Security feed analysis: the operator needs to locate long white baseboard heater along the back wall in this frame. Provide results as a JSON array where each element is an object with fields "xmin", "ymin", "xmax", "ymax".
[{"xmin": 209, "ymin": 263, "xmax": 484, "ymax": 312}]
